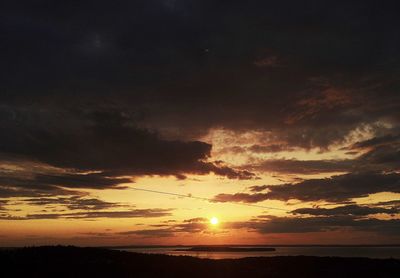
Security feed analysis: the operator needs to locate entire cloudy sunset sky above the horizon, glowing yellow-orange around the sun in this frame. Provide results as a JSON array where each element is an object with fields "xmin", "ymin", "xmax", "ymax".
[{"xmin": 0, "ymin": 0, "xmax": 400, "ymax": 246}]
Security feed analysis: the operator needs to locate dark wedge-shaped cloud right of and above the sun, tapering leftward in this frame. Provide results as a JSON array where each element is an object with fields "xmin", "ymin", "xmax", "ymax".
[{"xmin": 214, "ymin": 172, "xmax": 400, "ymax": 203}]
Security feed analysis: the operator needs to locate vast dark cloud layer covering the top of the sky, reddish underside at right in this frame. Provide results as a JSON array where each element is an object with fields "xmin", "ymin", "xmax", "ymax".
[{"xmin": 0, "ymin": 0, "xmax": 400, "ymax": 150}]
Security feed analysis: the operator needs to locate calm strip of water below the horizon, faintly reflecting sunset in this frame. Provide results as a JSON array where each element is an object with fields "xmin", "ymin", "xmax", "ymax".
[{"xmin": 119, "ymin": 247, "xmax": 400, "ymax": 259}]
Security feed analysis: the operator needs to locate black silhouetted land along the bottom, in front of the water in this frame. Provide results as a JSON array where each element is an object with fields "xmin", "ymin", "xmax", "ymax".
[{"xmin": 0, "ymin": 247, "xmax": 400, "ymax": 278}]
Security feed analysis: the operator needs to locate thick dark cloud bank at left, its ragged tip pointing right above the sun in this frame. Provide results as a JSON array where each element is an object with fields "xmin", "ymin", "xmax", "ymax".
[{"xmin": 0, "ymin": 107, "xmax": 254, "ymax": 181}]
